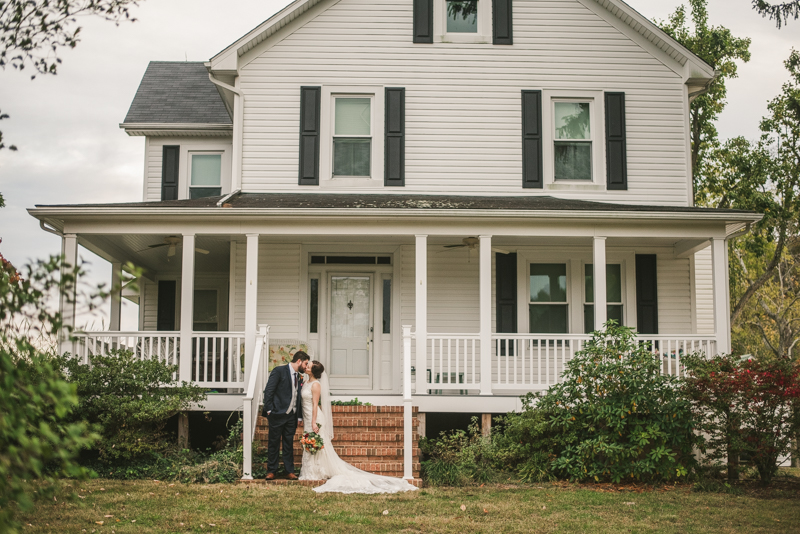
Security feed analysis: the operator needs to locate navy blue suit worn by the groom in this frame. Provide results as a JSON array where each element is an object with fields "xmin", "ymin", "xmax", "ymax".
[{"xmin": 261, "ymin": 364, "xmax": 303, "ymax": 473}]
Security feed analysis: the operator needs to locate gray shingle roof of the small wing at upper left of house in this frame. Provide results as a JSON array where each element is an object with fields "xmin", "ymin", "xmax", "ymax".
[{"xmin": 123, "ymin": 61, "xmax": 231, "ymax": 124}]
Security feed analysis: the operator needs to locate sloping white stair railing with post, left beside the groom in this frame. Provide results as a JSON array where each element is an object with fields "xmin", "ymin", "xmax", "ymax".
[{"xmin": 242, "ymin": 325, "xmax": 269, "ymax": 480}]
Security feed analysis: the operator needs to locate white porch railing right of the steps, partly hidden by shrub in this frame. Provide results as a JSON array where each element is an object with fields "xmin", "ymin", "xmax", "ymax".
[{"xmin": 408, "ymin": 332, "xmax": 717, "ymax": 394}]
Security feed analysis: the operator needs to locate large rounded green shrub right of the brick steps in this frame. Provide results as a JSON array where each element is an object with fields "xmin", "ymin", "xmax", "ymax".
[{"xmin": 522, "ymin": 321, "xmax": 695, "ymax": 482}]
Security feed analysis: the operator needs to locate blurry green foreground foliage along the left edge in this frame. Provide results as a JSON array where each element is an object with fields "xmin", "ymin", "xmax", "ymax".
[{"xmin": 0, "ymin": 256, "xmax": 97, "ymax": 532}]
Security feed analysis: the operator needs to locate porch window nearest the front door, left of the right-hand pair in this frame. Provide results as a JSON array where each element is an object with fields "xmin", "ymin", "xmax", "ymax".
[{"xmin": 528, "ymin": 263, "xmax": 569, "ymax": 334}]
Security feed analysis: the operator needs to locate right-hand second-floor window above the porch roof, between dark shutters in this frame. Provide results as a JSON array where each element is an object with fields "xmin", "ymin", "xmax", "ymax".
[{"xmin": 553, "ymin": 101, "xmax": 592, "ymax": 181}]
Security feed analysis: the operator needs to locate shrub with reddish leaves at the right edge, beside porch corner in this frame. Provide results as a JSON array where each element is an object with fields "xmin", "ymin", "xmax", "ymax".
[{"xmin": 684, "ymin": 355, "xmax": 800, "ymax": 484}]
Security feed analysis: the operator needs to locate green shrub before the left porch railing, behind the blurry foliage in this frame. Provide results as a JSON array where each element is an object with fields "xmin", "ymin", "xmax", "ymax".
[{"xmin": 60, "ymin": 351, "xmax": 205, "ymax": 461}]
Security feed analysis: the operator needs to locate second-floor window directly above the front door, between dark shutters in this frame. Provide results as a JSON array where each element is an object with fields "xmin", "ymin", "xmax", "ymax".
[{"xmin": 333, "ymin": 96, "xmax": 372, "ymax": 177}]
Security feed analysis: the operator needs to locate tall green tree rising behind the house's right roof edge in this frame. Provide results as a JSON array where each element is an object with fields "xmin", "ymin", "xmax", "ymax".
[{"xmin": 659, "ymin": 0, "xmax": 750, "ymax": 203}]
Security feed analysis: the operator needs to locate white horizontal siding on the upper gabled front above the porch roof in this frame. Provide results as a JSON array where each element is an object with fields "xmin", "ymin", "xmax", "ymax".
[{"xmin": 241, "ymin": 0, "xmax": 688, "ymax": 205}]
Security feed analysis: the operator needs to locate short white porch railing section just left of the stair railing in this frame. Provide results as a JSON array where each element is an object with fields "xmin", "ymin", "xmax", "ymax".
[{"xmin": 192, "ymin": 332, "xmax": 245, "ymax": 388}]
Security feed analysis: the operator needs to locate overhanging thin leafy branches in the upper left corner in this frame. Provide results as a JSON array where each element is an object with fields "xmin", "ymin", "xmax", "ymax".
[{"xmin": 0, "ymin": 0, "xmax": 139, "ymax": 150}]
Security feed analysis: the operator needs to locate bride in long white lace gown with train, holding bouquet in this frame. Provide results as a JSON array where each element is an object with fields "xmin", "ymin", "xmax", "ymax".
[{"xmin": 300, "ymin": 361, "xmax": 417, "ymax": 493}]
